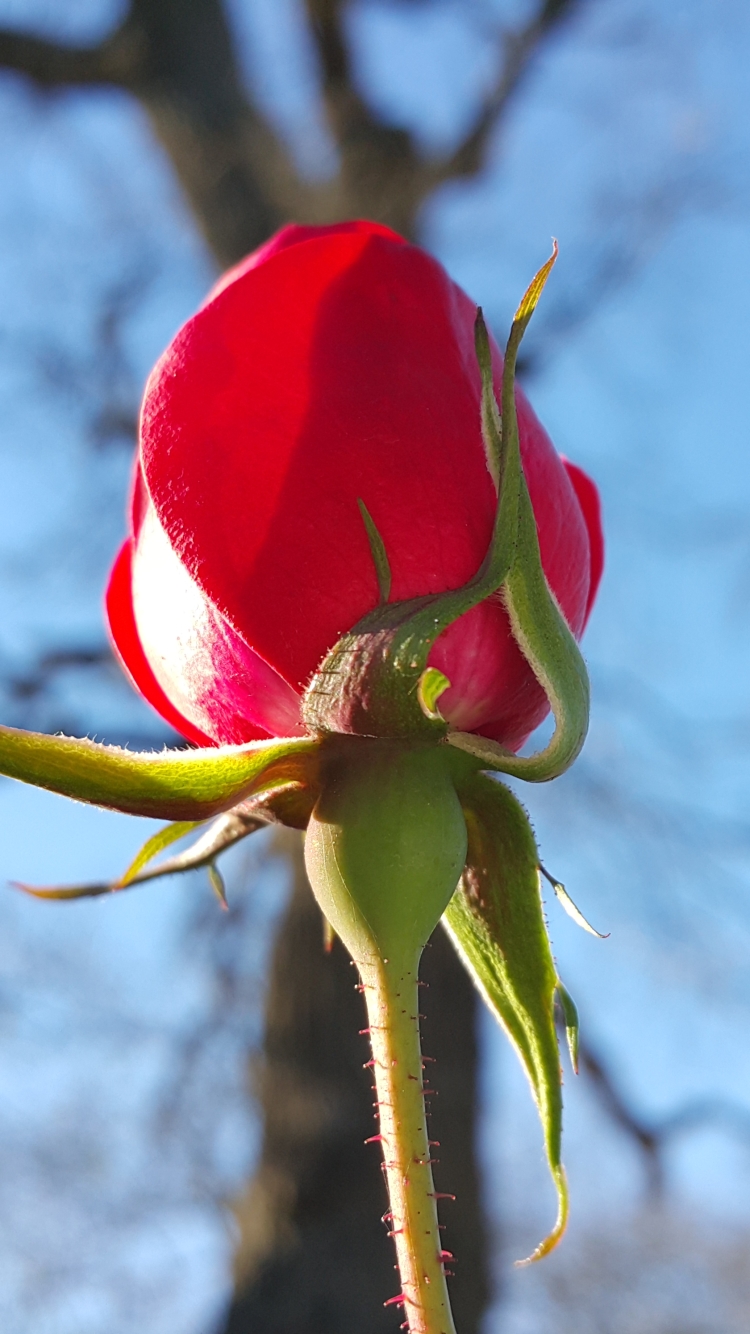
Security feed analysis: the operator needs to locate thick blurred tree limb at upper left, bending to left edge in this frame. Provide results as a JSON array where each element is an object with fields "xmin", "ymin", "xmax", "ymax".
[{"xmin": 0, "ymin": 0, "xmax": 300, "ymax": 267}]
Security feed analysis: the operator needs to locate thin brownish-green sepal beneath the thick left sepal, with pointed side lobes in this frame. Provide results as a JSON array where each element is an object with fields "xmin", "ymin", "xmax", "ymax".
[{"xmin": 15, "ymin": 807, "xmax": 268, "ymax": 900}]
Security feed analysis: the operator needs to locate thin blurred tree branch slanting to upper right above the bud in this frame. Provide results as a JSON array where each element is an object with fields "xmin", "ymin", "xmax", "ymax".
[{"xmin": 428, "ymin": 0, "xmax": 581, "ymax": 188}]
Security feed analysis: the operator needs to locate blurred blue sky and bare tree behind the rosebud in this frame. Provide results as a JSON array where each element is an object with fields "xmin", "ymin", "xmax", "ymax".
[{"xmin": 0, "ymin": 0, "xmax": 750, "ymax": 1334}]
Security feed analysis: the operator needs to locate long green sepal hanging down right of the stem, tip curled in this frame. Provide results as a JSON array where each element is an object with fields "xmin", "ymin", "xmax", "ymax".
[{"xmin": 443, "ymin": 772, "xmax": 567, "ymax": 1261}]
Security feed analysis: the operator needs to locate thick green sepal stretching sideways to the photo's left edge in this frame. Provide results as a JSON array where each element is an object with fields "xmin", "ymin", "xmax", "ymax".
[{"xmin": 0, "ymin": 727, "xmax": 318, "ymax": 820}]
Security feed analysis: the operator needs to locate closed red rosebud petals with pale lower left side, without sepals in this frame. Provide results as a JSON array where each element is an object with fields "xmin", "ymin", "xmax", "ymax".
[{"xmin": 107, "ymin": 223, "xmax": 602, "ymax": 748}]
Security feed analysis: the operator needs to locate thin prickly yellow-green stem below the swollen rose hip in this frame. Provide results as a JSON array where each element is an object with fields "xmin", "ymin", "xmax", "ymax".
[{"xmin": 359, "ymin": 960, "xmax": 455, "ymax": 1334}]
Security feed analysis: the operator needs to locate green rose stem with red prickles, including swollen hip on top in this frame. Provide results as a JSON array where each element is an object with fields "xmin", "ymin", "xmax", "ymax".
[{"xmin": 304, "ymin": 736, "xmax": 467, "ymax": 1334}]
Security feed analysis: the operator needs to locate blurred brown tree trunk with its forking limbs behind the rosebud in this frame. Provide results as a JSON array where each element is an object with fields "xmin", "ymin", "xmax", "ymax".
[{"xmin": 0, "ymin": 0, "xmax": 577, "ymax": 1334}]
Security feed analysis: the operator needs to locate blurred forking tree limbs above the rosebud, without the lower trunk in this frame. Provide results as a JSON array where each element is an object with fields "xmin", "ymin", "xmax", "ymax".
[{"xmin": 0, "ymin": 0, "xmax": 581, "ymax": 254}]
